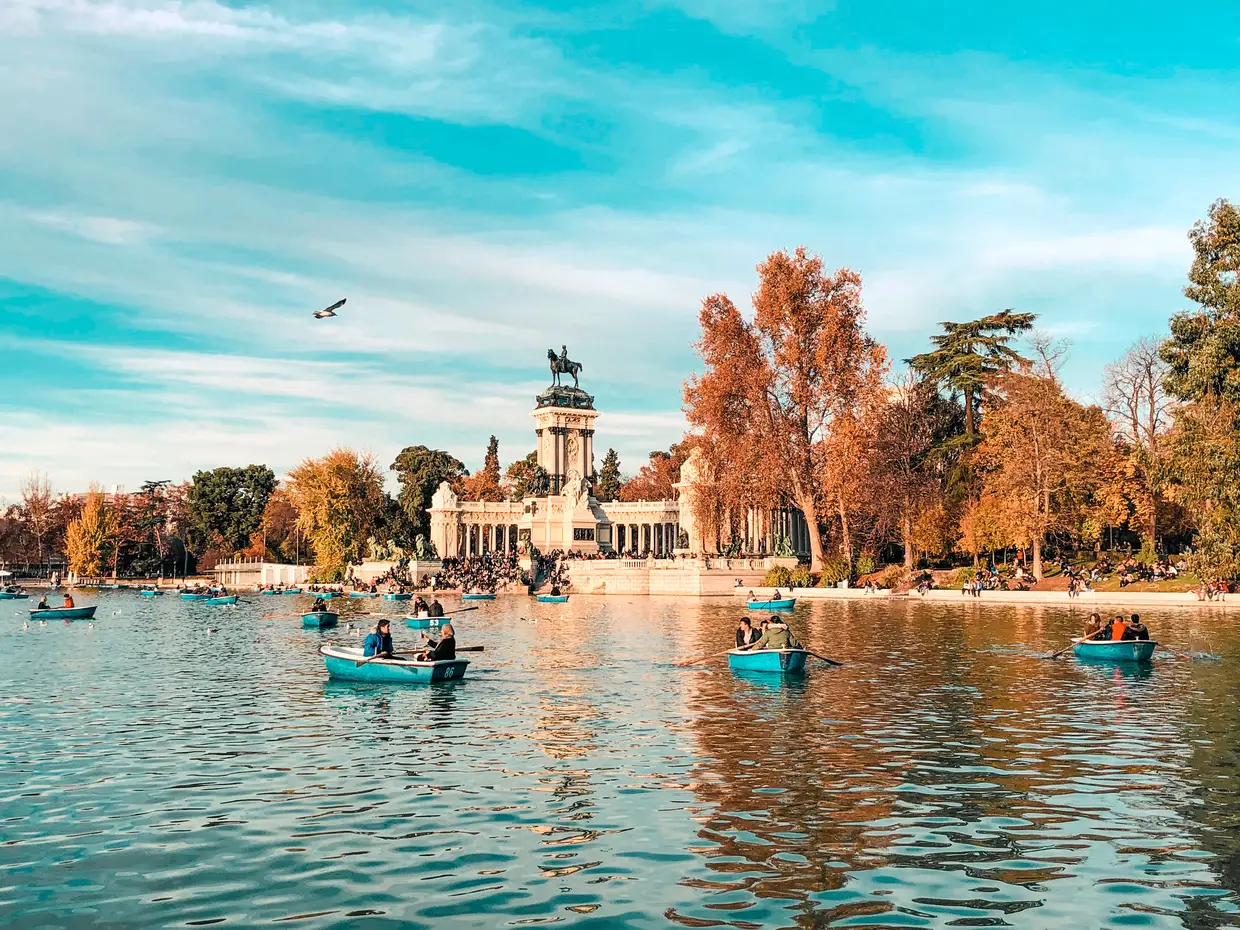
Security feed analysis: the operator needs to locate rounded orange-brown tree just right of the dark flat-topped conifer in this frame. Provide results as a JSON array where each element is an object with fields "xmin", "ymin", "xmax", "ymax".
[{"xmin": 977, "ymin": 366, "xmax": 1116, "ymax": 582}]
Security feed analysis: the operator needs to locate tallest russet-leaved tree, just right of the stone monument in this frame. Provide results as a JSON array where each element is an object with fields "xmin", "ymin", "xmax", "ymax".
[{"xmin": 684, "ymin": 247, "xmax": 887, "ymax": 572}]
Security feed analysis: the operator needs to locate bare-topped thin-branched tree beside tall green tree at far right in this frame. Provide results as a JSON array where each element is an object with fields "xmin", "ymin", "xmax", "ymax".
[{"xmin": 1102, "ymin": 339, "xmax": 1173, "ymax": 549}]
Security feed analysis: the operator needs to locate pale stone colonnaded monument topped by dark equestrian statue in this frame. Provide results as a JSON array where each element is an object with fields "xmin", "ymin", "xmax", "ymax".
[{"xmin": 429, "ymin": 347, "xmax": 808, "ymax": 594}]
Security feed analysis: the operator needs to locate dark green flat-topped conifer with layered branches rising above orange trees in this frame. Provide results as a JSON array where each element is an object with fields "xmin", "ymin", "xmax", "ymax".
[{"xmin": 906, "ymin": 309, "xmax": 1038, "ymax": 441}]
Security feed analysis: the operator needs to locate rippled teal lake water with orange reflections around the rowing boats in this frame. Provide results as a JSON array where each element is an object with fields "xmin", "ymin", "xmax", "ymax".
[{"xmin": 0, "ymin": 591, "xmax": 1240, "ymax": 928}]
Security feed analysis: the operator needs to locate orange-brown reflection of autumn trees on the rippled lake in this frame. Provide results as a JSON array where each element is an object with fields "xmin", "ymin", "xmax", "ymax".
[{"xmin": 668, "ymin": 603, "xmax": 1240, "ymax": 926}]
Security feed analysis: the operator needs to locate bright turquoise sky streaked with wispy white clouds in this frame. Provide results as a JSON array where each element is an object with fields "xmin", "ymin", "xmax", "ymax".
[{"xmin": 0, "ymin": 0, "xmax": 1240, "ymax": 502}]
